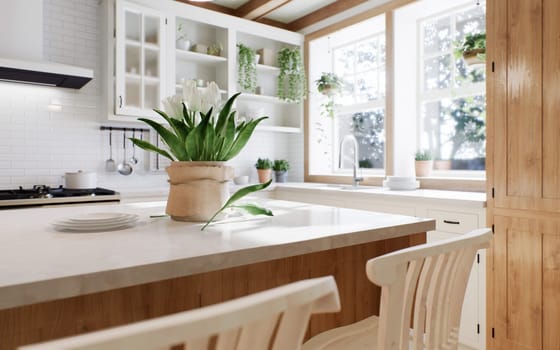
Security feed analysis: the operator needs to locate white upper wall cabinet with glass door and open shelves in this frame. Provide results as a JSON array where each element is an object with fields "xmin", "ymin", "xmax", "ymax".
[{"xmin": 104, "ymin": 0, "xmax": 303, "ymax": 132}]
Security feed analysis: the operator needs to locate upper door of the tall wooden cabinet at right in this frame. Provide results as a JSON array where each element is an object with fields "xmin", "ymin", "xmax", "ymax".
[{"xmin": 487, "ymin": 0, "xmax": 560, "ymax": 212}]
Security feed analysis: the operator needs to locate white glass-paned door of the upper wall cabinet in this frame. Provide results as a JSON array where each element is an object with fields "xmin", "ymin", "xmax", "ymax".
[{"xmin": 115, "ymin": 1, "xmax": 165, "ymax": 117}]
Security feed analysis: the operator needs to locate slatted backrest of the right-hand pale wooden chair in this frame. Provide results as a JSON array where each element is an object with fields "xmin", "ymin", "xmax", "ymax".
[{"xmin": 366, "ymin": 229, "xmax": 492, "ymax": 350}]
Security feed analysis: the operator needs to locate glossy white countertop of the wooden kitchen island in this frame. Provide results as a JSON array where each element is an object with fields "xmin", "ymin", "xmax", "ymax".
[{"xmin": 0, "ymin": 198, "xmax": 435, "ymax": 309}]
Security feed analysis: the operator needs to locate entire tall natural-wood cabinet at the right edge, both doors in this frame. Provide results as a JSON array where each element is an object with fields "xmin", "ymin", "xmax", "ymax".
[{"xmin": 487, "ymin": 0, "xmax": 560, "ymax": 350}]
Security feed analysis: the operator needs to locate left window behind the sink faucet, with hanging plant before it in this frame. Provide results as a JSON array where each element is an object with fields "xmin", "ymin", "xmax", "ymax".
[{"xmin": 309, "ymin": 16, "xmax": 386, "ymax": 174}]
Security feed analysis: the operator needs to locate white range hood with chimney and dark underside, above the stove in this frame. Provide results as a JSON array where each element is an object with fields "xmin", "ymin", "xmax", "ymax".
[{"xmin": 0, "ymin": 0, "xmax": 93, "ymax": 89}]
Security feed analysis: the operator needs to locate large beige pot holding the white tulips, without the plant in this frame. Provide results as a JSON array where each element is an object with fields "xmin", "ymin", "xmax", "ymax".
[{"xmin": 165, "ymin": 162, "xmax": 234, "ymax": 221}]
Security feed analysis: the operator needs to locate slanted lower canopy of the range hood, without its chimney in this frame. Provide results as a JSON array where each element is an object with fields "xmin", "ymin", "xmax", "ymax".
[{"xmin": 0, "ymin": 58, "xmax": 93, "ymax": 89}]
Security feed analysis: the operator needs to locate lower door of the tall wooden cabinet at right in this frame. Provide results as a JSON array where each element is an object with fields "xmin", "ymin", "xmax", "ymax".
[{"xmin": 489, "ymin": 216, "xmax": 560, "ymax": 350}]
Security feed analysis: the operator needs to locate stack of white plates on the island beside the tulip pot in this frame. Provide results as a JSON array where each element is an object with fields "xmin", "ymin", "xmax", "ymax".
[{"xmin": 52, "ymin": 213, "xmax": 138, "ymax": 232}]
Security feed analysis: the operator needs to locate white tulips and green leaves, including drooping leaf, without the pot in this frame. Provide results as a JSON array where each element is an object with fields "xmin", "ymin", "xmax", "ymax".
[{"xmin": 130, "ymin": 80, "xmax": 272, "ymax": 229}]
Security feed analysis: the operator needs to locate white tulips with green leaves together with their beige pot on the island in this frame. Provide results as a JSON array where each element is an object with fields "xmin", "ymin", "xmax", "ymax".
[{"xmin": 130, "ymin": 80, "xmax": 272, "ymax": 229}]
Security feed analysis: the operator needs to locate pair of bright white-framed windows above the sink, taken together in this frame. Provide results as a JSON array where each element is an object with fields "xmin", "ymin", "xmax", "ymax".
[{"xmin": 306, "ymin": 0, "xmax": 486, "ymax": 185}]
